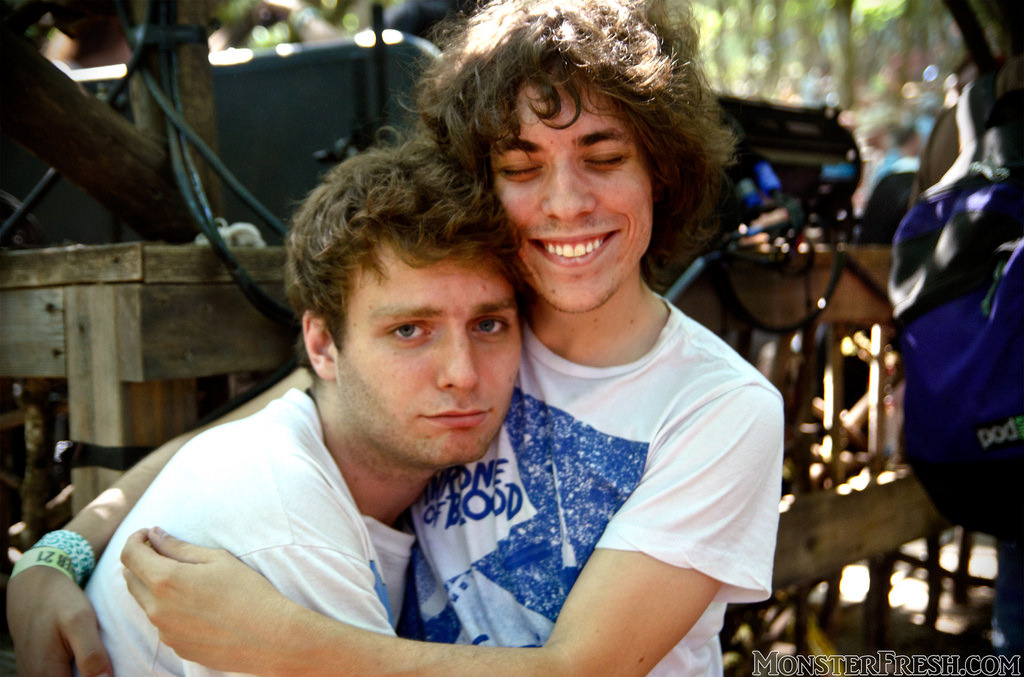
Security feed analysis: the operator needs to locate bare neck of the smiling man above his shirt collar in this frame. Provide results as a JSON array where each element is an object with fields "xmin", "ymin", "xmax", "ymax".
[{"xmin": 529, "ymin": 280, "xmax": 669, "ymax": 367}]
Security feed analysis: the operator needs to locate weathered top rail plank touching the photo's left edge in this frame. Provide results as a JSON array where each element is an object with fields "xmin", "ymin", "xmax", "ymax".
[{"xmin": 0, "ymin": 243, "xmax": 143, "ymax": 289}]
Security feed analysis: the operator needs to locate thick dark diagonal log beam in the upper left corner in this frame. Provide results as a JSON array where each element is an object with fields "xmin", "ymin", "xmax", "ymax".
[{"xmin": 0, "ymin": 27, "xmax": 196, "ymax": 242}]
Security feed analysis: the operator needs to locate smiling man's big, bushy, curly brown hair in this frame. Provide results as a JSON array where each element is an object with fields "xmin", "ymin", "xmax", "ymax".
[{"xmin": 417, "ymin": 0, "xmax": 734, "ymax": 283}]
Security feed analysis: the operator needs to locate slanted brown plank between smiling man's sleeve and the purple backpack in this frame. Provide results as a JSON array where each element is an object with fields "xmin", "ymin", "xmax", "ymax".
[{"xmin": 773, "ymin": 475, "xmax": 949, "ymax": 588}]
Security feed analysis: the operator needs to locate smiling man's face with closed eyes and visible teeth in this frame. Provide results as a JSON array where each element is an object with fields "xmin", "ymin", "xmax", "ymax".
[{"xmin": 490, "ymin": 89, "xmax": 654, "ymax": 313}]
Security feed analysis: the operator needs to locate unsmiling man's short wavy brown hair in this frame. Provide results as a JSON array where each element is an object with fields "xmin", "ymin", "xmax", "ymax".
[{"xmin": 285, "ymin": 138, "xmax": 522, "ymax": 348}]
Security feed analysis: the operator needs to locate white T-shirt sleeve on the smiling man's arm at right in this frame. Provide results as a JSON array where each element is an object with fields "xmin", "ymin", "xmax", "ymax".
[{"xmin": 597, "ymin": 384, "xmax": 783, "ymax": 602}]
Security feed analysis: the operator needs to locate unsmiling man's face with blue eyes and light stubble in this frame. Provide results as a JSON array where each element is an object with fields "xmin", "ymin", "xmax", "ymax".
[{"xmin": 304, "ymin": 250, "xmax": 520, "ymax": 475}]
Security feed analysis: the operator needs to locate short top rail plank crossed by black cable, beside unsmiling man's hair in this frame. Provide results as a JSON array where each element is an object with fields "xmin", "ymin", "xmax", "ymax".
[{"xmin": 143, "ymin": 244, "xmax": 285, "ymax": 284}]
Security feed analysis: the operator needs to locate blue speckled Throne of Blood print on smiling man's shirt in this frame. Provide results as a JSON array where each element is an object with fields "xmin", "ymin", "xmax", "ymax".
[{"xmin": 399, "ymin": 388, "xmax": 648, "ymax": 646}]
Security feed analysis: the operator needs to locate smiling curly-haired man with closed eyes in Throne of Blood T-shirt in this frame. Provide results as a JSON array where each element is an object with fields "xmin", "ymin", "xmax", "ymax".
[{"xmin": 8, "ymin": 0, "xmax": 782, "ymax": 676}]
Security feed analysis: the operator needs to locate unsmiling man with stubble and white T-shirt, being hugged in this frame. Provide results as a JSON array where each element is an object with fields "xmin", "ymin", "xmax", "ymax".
[{"xmin": 18, "ymin": 141, "xmax": 521, "ymax": 675}]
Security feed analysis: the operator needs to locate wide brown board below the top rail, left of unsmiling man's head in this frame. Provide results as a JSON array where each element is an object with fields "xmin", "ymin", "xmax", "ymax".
[{"xmin": 118, "ymin": 284, "xmax": 297, "ymax": 382}]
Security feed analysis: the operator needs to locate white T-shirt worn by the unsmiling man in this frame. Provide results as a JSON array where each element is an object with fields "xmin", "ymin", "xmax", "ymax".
[{"xmin": 85, "ymin": 390, "xmax": 413, "ymax": 676}]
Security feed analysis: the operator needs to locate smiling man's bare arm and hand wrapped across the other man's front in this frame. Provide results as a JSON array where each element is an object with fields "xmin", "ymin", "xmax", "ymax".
[{"xmin": 130, "ymin": 530, "xmax": 704, "ymax": 677}]
